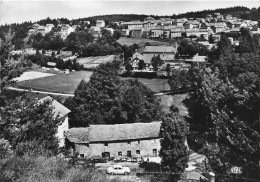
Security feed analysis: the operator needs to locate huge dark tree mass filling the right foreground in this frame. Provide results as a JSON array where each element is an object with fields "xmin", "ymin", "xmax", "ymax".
[{"xmin": 186, "ymin": 69, "xmax": 260, "ymax": 179}]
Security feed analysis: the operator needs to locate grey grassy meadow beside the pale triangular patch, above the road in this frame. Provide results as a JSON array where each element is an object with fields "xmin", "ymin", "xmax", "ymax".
[{"xmin": 17, "ymin": 71, "xmax": 92, "ymax": 94}]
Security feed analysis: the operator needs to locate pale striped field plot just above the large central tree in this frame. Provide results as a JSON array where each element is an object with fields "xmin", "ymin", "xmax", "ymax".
[{"xmin": 77, "ymin": 55, "xmax": 118, "ymax": 68}]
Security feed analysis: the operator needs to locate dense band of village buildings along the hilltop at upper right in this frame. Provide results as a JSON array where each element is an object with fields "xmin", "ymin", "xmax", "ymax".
[{"xmin": 115, "ymin": 13, "xmax": 260, "ymax": 39}]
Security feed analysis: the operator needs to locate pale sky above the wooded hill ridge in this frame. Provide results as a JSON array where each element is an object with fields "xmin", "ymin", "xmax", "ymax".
[{"xmin": 0, "ymin": 0, "xmax": 260, "ymax": 24}]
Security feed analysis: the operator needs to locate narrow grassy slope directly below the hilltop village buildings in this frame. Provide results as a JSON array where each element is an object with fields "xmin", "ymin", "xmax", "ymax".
[{"xmin": 118, "ymin": 37, "xmax": 169, "ymax": 46}]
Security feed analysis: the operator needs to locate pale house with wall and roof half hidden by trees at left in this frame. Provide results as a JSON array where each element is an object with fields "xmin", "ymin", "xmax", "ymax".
[{"xmin": 39, "ymin": 96, "xmax": 70, "ymax": 147}]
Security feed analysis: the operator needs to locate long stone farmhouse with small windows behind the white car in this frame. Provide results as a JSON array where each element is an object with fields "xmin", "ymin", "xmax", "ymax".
[{"xmin": 65, "ymin": 122, "xmax": 161, "ymax": 158}]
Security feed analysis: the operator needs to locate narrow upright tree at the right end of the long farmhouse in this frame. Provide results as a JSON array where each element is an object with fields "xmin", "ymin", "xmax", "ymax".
[{"xmin": 159, "ymin": 113, "xmax": 188, "ymax": 173}]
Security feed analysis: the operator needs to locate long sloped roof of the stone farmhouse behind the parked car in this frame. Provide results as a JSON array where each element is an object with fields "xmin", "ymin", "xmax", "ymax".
[{"xmin": 66, "ymin": 122, "xmax": 161, "ymax": 143}]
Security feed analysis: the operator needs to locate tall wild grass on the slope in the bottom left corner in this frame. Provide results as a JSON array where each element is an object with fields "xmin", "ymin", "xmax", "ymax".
[{"xmin": 0, "ymin": 155, "xmax": 148, "ymax": 182}]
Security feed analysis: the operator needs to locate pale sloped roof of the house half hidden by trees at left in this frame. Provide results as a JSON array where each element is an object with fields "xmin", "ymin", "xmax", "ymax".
[{"xmin": 39, "ymin": 96, "xmax": 70, "ymax": 117}]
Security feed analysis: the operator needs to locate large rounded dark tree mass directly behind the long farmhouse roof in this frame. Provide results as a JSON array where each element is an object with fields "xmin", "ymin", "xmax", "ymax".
[{"xmin": 66, "ymin": 62, "xmax": 161, "ymax": 127}]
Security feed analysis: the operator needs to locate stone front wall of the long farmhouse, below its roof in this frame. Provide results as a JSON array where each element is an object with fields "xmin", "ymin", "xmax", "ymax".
[{"xmin": 75, "ymin": 138, "xmax": 161, "ymax": 158}]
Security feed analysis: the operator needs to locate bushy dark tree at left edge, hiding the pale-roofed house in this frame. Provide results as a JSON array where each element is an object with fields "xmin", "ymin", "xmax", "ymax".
[{"xmin": 1, "ymin": 97, "xmax": 61, "ymax": 153}]
